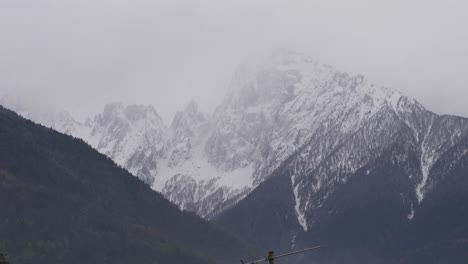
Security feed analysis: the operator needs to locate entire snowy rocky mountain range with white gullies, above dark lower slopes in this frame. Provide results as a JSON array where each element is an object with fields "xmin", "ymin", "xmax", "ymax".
[{"xmin": 3, "ymin": 50, "xmax": 467, "ymax": 235}]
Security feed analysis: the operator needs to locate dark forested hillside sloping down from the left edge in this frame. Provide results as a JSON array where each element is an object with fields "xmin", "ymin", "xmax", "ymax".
[{"xmin": 0, "ymin": 108, "xmax": 250, "ymax": 264}]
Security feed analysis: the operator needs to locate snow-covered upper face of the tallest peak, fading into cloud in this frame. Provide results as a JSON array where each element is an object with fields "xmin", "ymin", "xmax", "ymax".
[{"xmin": 207, "ymin": 50, "xmax": 413, "ymax": 181}]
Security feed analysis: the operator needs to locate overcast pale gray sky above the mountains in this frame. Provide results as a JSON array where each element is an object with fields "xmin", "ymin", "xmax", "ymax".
[{"xmin": 0, "ymin": 0, "xmax": 468, "ymax": 122}]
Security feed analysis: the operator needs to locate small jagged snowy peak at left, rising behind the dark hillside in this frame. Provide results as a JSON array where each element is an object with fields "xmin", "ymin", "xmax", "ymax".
[{"xmin": 87, "ymin": 103, "xmax": 169, "ymax": 184}]
